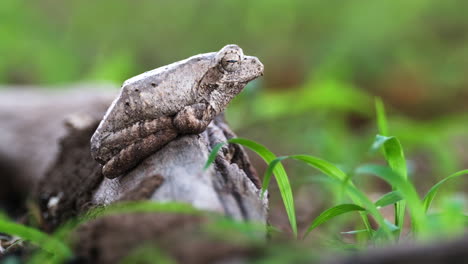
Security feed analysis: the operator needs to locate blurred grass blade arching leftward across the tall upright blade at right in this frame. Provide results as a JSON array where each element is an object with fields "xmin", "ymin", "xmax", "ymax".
[{"xmin": 356, "ymin": 165, "xmax": 427, "ymax": 235}]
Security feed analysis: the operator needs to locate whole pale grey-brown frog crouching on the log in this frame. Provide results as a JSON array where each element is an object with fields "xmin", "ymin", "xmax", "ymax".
[{"xmin": 91, "ymin": 45, "xmax": 263, "ymax": 178}]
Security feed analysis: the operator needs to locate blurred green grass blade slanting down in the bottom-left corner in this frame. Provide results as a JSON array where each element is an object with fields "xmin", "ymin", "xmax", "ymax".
[{"xmin": 0, "ymin": 218, "xmax": 72, "ymax": 259}]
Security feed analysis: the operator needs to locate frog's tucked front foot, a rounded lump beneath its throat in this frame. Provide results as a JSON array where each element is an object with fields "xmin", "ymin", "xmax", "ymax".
[{"xmin": 173, "ymin": 103, "xmax": 216, "ymax": 134}]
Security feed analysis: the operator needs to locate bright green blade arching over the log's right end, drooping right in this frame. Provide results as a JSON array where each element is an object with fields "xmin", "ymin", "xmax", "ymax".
[{"xmin": 205, "ymin": 138, "xmax": 297, "ymax": 237}]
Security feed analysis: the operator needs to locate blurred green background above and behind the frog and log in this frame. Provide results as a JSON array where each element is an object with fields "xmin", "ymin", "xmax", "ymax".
[{"xmin": 0, "ymin": 0, "xmax": 468, "ymax": 235}]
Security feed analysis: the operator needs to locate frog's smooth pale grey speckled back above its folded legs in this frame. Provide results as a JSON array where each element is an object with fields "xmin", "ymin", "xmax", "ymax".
[{"xmin": 98, "ymin": 53, "xmax": 215, "ymax": 135}]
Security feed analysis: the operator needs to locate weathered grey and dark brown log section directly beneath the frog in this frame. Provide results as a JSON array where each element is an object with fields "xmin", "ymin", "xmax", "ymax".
[{"xmin": 37, "ymin": 108, "xmax": 267, "ymax": 228}]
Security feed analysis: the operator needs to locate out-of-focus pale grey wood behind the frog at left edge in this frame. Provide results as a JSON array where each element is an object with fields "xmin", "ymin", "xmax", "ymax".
[{"xmin": 0, "ymin": 84, "xmax": 117, "ymax": 215}]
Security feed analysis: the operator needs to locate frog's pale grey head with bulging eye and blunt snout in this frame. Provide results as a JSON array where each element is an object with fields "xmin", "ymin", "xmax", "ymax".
[{"xmin": 215, "ymin": 45, "xmax": 263, "ymax": 83}]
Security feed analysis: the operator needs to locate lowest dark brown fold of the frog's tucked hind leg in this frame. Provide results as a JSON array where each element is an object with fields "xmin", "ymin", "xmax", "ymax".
[{"xmin": 102, "ymin": 129, "xmax": 177, "ymax": 179}]
